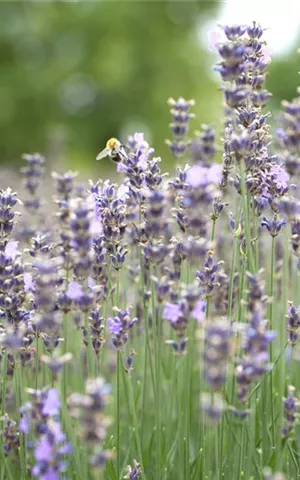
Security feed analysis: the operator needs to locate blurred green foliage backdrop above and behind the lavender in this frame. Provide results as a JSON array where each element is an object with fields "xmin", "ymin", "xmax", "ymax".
[{"xmin": 0, "ymin": 0, "xmax": 298, "ymax": 171}]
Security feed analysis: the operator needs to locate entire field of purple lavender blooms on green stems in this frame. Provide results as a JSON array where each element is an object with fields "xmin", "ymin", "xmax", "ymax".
[{"xmin": 0, "ymin": 23, "xmax": 300, "ymax": 480}]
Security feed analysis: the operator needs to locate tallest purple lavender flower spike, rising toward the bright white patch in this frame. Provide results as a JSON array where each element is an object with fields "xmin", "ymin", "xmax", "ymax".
[{"xmin": 216, "ymin": 22, "xmax": 287, "ymax": 209}]
